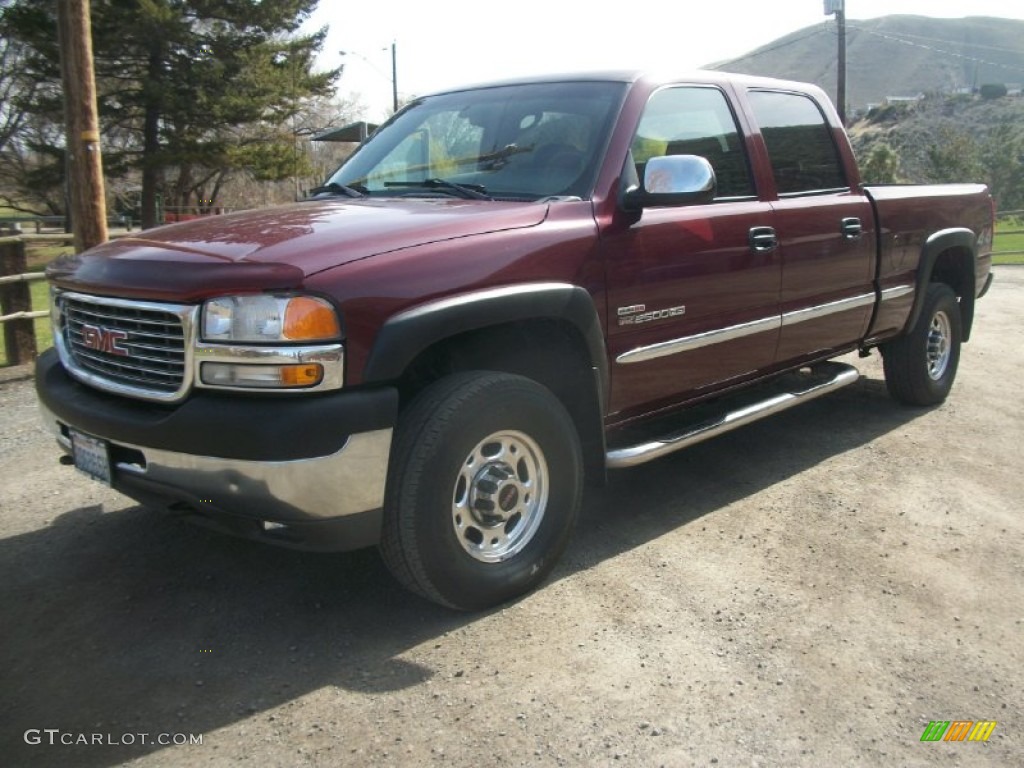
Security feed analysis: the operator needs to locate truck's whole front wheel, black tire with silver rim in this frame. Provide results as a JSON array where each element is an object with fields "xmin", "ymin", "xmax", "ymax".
[{"xmin": 380, "ymin": 372, "xmax": 583, "ymax": 610}]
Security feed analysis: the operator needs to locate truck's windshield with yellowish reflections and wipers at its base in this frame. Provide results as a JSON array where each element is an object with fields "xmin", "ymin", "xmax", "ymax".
[{"xmin": 329, "ymin": 82, "xmax": 625, "ymax": 200}]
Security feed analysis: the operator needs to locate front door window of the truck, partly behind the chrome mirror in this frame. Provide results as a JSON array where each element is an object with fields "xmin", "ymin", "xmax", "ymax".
[{"xmin": 632, "ymin": 86, "xmax": 754, "ymax": 200}]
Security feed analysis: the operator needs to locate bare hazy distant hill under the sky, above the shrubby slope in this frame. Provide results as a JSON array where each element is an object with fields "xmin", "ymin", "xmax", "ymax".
[{"xmin": 713, "ymin": 15, "xmax": 1024, "ymax": 111}]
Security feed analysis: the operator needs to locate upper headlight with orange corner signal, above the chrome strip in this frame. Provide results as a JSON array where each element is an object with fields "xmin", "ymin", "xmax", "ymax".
[{"xmin": 203, "ymin": 294, "xmax": 341, "ymax": 344}]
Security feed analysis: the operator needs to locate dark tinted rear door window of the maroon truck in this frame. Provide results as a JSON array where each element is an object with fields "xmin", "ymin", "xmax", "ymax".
[{"xmin": 749, "ymin": 91, "xmax": 849, "ymax": 195}]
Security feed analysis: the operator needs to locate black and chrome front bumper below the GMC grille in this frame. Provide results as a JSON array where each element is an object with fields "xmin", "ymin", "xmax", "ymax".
[{"xmin": 36, "ymin": 350, "xmax": 398, "ymax": 551}]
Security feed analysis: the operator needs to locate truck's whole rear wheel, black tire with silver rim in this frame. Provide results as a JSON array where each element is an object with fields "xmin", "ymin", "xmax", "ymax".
[{"xmin": 882, "ymin": 283, "xmax": 963, "ymax": 406}]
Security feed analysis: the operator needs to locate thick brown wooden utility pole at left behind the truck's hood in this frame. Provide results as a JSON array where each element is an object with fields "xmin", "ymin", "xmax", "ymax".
[{"xmin": 57, "ymin": 0, "xmax": 108, "ymax": 253}]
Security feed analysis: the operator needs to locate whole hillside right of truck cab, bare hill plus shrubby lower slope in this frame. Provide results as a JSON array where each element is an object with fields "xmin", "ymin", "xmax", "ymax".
[{"xmin": 713, "ymin": 15, "xmax": 1024, "ymax": 217}]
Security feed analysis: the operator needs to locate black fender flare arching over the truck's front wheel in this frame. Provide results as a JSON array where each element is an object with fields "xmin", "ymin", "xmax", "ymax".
[{"xmin": 362, "ymin": 283, "xmax": 610, "ymax": 412}]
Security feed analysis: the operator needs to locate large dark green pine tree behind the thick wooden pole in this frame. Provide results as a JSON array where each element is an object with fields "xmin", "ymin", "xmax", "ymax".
[{"xmin": 7, "ymin": 0, "xmax": 339, "ymax": 226}]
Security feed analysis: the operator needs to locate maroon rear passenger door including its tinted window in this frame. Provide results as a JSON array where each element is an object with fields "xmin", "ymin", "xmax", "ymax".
[{"xmin": 746, "ymin": 89, "xmax": 876, "ymax": 364}]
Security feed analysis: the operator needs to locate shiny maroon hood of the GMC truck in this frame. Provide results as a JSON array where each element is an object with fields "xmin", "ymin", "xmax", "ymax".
[{"xmin": 47, "ymin": 198, "xmax": 548, "ymax": 301}]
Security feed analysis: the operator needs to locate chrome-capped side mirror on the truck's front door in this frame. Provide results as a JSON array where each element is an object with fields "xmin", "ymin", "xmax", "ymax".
[{"xmin": 623, "ymin": 155, "xmax": 718, "ymax": 211}]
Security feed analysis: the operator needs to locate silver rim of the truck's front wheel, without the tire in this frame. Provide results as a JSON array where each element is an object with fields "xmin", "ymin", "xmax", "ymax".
[{"xmin": 452, "ymin": 431, "xmax": 548, "ymax": 563}]
